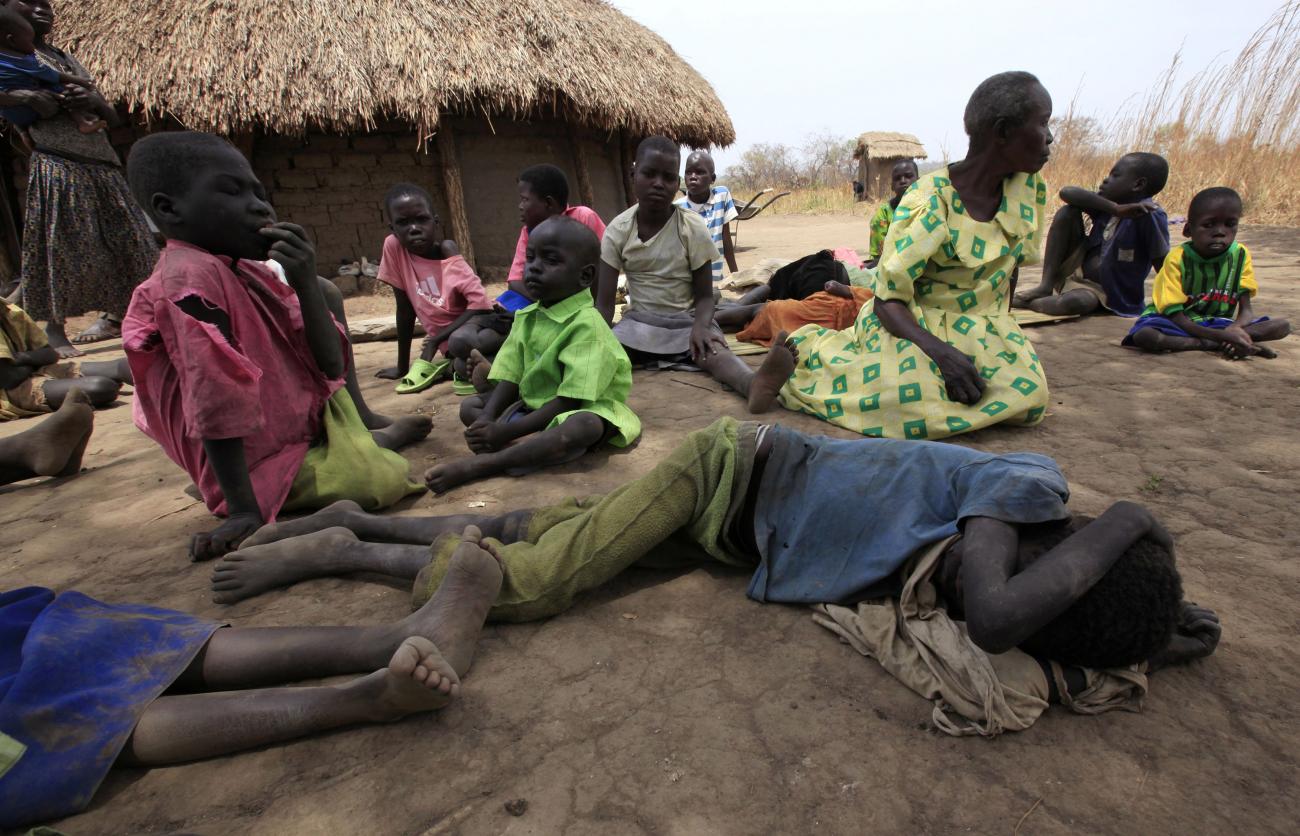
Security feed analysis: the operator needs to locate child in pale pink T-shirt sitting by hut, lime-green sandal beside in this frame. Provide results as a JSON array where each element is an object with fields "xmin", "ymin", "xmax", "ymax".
[{"xmin": 376, "ymin": 183, "xmax": 491, "ymax": 395}]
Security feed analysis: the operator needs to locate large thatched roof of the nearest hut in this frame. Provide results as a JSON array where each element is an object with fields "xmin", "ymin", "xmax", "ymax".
[{"xmin": 51, "ymin": 0, "xmax": 736, "ymax": 146}]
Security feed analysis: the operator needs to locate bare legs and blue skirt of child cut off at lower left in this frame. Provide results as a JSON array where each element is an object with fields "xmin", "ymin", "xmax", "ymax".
[{"xmin": 0, "ymin": 529, "xmax": 502, "ymax": 829}]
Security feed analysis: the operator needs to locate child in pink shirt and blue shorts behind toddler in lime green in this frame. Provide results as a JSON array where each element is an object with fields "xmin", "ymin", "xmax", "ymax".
[{"xmin": 447, "ymin": 165, "xmax": 605, "ymax": 384}]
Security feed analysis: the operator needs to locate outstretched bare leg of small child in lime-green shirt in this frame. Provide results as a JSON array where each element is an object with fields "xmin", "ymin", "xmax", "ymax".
[{"xmin": 424, "ymin": 413, "xmax": 608, "ymax": 494}]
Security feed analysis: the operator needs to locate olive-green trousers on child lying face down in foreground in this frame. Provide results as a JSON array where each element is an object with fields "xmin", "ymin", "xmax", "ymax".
[{"xmin": 413, "ymin": 417, "xmax": 758, "ymax": 621}]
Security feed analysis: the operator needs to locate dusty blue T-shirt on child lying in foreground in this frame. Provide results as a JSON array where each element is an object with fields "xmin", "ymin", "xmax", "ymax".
[{"xmin": 749, "ymin": 426, "xmax": 1070, "ymax": 603}]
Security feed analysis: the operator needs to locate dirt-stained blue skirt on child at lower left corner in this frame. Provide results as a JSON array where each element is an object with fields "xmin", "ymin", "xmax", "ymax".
[{"xmin": 0, "ymin": 586, "xmax": 220, "ymax": 828}]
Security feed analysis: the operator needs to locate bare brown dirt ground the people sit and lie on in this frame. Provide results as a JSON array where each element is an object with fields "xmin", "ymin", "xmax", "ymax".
[{"xmin": 0, "ymin": 217, "xmax": 1300, "ymax": 835}]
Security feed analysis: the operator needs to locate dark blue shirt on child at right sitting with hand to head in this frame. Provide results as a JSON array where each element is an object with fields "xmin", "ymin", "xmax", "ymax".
[{"xmin": 1086, "ymin": 205, "xmax": 1169, "ymax": 316}]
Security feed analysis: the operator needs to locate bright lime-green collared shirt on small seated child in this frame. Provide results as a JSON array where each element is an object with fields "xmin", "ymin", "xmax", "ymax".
[{"xmin": 489, "ymin": 289, "xmax": 641, "ymax": 447}]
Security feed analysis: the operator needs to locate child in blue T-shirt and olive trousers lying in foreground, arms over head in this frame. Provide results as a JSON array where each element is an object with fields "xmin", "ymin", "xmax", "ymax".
[{"xmin": 212, "ymin": 419, "xmax": 1219, "ymax": 733}]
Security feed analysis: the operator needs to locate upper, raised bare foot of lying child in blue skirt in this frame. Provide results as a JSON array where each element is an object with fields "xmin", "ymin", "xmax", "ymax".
[{"xmin": 397, "ymin": 525, "xmax": 503, "ymax": 676}]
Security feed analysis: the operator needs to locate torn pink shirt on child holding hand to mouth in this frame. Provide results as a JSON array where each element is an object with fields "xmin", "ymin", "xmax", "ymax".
[{"xmin": 122, "ymin": 241, "xmax": 347, "ymax": 523}]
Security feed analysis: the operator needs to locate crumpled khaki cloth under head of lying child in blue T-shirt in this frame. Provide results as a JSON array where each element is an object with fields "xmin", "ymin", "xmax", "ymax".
[{"xmin": 813, "ymin": 537, "xmax": 1147, "ymax": 737}]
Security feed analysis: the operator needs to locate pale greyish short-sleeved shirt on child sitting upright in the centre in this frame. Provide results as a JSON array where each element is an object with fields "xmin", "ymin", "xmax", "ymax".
[{"xmin": 601, "ymin": 204, "xmax": 722, "ymax": 313}]
